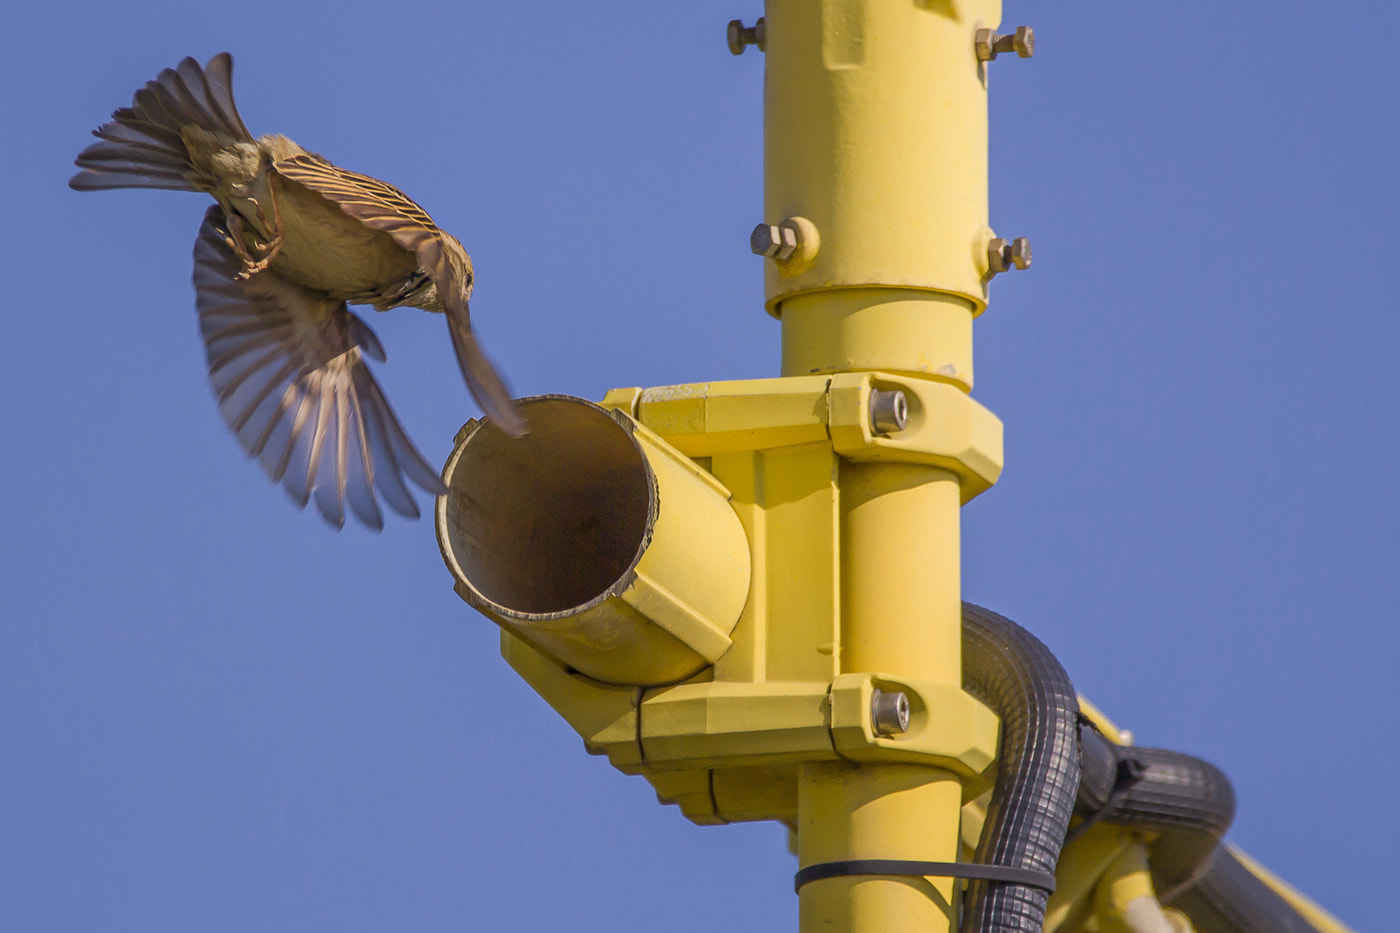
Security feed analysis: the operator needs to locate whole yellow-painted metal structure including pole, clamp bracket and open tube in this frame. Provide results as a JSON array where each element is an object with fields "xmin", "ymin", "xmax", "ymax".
[{"xmin": 438, "ymin": 0, "xmax": 1366, "ymax": 933}]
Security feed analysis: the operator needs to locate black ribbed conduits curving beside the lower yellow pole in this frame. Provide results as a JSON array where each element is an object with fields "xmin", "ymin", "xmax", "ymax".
[{"xmin": 960, "ymin": 602, "xmax": 1317, "ymax": 933}]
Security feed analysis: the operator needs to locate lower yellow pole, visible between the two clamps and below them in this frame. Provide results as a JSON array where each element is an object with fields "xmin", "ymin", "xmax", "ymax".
[{"xmin": 798, "ymin": 464, "xmax": 962, "ymax": 933}]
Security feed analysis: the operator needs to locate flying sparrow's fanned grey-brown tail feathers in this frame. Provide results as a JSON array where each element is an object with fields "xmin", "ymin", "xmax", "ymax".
[{"xmin": 69, "ymin": 52, "xmax": 252, "ymax": 191}]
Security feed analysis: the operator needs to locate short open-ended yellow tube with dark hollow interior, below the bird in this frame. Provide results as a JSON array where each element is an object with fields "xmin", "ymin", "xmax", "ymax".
[{"xmin": 437, "ymin": 396, "xmax": 750, "ymax": 685}]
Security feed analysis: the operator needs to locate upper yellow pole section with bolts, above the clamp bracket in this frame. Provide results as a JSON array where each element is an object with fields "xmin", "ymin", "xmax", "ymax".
[{"xmin": 764, "ymin": 0, "xmax": 1001, "ymax": 387}]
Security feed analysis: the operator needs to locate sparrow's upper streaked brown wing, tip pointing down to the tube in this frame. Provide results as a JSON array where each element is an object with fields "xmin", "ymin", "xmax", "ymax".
[{"xmin": 273, "ymin": 154, "xmax": 525, "ymax": 437}]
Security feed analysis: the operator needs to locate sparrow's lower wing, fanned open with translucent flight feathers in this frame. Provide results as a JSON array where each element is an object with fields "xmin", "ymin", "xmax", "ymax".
[{"xmin": 195, "ymin": 206, "xmax": 447, "ymax": 530}]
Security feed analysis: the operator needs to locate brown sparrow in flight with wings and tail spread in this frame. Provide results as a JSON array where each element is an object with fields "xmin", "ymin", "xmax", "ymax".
[{"xmin": 69, "ymin": 52, "xmax": 528, "ymax": 531}]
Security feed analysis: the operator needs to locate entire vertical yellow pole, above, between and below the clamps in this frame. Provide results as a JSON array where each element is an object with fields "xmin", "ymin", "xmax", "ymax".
[{"xmin": 764, "ymin": 0, "xmax": 1001, "ymax": 933}]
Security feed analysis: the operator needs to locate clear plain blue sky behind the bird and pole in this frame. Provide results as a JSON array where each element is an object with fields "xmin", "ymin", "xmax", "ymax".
[{"xmin": 0, "ymin": 0, "xmax": 1400, "ymax": 933}]
